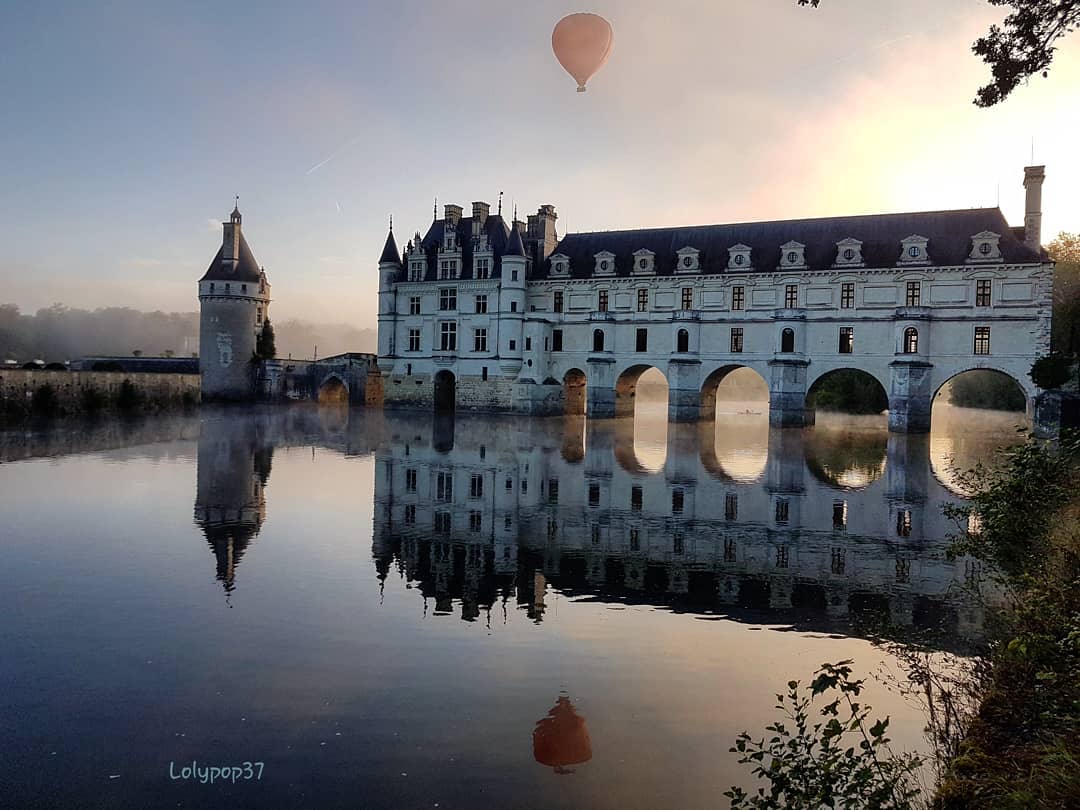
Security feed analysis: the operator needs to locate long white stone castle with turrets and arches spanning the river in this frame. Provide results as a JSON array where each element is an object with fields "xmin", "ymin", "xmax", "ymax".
[{"xmin": 375, "ymin": 166, "xmax": 1053, "ymax": 432}]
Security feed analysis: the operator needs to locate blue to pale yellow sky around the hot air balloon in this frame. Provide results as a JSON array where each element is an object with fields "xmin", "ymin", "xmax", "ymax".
[{"xmin": 0, "ymin": 0, "xmax": 1080, "ymax": 327}]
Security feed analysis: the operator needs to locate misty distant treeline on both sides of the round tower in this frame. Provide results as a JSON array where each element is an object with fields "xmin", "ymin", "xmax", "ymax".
[{"xmin": 0, "ymin": 303, "xmax": 376, "ymax": 363}]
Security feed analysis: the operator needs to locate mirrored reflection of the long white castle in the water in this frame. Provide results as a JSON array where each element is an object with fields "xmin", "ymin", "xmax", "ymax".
[{"xmin": 374, "ymin": 415, "xmax": 982, "ymax": 634}]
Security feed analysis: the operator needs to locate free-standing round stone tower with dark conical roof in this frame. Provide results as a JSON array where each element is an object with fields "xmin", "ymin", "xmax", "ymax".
[{"xmin": 199, "ymin": 206, "xmax": 270, "ymax": 401}]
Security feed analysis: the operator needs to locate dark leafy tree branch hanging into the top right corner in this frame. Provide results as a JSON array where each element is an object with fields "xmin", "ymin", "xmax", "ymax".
[{"xmin": 798, "ymin": 0, "xmax": 1080, "ymax": 107}]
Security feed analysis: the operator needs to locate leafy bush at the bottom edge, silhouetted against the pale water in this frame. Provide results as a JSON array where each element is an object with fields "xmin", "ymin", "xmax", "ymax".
[{"xmin": 724, "ymin": 661, "xmax": 922, "ymax": 810}]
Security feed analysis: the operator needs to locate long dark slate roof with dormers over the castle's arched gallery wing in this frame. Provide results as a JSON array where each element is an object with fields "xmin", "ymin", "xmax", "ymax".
[{"xmin": 532, "ymin": 208, "xmax": 1045, "ymax": 279}]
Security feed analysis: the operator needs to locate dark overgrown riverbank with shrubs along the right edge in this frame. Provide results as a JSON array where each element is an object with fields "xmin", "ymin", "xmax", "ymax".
[{"xmin": 934, "ymin": 438, "xmax": 1080, "ymax": 808}]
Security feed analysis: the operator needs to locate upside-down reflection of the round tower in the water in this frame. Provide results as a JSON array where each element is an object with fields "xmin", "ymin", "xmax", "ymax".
[{"xmin": 194, "ymin": 419, "xmax": 273, "ymax": 594}]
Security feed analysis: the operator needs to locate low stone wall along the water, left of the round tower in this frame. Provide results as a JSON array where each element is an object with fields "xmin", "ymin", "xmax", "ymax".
[{"xmin": 0, "ymin": 369, "xmax": 201, "ymax": 419}]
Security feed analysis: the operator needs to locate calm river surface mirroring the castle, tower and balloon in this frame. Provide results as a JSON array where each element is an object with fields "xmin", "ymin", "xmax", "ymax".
[{"xmin": 0, "ymin": 406, "xmax": 1016, "ymax": 808}]
